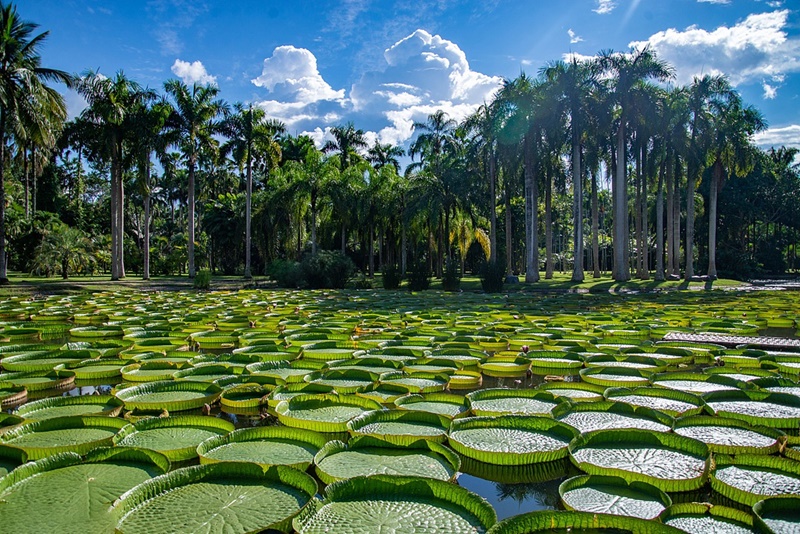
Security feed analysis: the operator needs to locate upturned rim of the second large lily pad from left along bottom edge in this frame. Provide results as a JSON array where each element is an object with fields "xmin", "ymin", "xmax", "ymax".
[{"xmin": 111, "ymin": 462, "xmax": 318, "ymax": 532}]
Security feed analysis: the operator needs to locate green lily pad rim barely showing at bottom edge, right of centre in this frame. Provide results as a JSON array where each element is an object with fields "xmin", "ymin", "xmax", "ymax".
[{"xmin": 486, "ymin": 510, "xmax": 686, "ymax": 534}]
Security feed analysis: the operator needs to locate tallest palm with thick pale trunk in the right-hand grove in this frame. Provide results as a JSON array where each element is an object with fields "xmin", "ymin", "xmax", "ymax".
[{"xmin": 598, "ymin": 47, "xmax": 674, "ymax": 281}]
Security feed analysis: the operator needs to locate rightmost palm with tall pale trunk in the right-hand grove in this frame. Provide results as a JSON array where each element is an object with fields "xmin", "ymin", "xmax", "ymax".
[{"xmin": 706, "ymin": 89, "xmax": 766, "ymax": 279}]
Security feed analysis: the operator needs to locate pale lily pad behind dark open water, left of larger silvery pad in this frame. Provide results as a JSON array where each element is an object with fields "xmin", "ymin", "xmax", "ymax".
[{"xmin": 448, "ymin": 415, "xmax": 577, "ymax": 465}]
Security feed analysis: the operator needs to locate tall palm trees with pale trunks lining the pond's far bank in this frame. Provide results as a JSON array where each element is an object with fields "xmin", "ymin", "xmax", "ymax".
[{"xmin": 0, "ymin": 5, "xmax": 788, "ymax": 282}]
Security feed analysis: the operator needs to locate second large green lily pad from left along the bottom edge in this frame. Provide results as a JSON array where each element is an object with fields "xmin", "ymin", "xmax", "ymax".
[{"xmin": 114, "ymin": 462, "xmax": 317, "ymax": 534}]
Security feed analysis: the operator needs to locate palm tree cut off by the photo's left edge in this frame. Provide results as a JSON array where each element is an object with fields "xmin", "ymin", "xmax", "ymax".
[{"xmin": 0, "ymin": 4, "xmax": 73, "ymax": 284}]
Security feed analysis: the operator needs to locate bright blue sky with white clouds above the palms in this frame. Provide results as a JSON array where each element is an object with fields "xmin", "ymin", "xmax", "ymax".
[{"xmin": 18, "ymin": 0, "xmax": 800, "ymax": 154}]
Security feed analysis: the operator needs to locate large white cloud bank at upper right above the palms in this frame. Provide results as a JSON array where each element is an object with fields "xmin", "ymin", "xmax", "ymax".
[{"xmin": 630, "ymin": 10, "xmax": 800, "ymax": 85}]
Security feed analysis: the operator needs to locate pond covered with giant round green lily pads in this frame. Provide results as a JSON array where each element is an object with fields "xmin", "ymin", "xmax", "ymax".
[{"xmin": 0, "ymin": 290, "xmax": 800, "ymax": 534}]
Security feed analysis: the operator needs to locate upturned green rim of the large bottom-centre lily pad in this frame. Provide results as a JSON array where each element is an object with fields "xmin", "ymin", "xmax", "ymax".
[{"xmin": 292, "ymin": 475, "xmax": 497, "ymax": 532}]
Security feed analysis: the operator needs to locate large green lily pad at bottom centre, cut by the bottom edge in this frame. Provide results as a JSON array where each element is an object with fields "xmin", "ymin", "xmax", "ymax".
[{"xmin": 293, "ymin": 475, "xmax": 497, "ymax": 534}]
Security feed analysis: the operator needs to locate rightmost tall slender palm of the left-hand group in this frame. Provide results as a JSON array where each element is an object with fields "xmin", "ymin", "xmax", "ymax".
[{"xmin": 220, "ymin": 103, "xmax": 286, "ymax": 279}]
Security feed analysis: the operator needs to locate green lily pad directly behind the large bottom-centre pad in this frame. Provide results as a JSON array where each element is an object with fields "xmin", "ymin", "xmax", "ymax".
[{"xmin": 314, "ymin": 436, "xmax": 461, "ymax": 484}]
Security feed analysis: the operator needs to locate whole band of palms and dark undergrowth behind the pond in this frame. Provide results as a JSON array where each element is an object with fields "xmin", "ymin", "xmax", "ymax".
[{"xmin": 0, "ymin": 4, "xmax": 800, "ymax": 282}]
